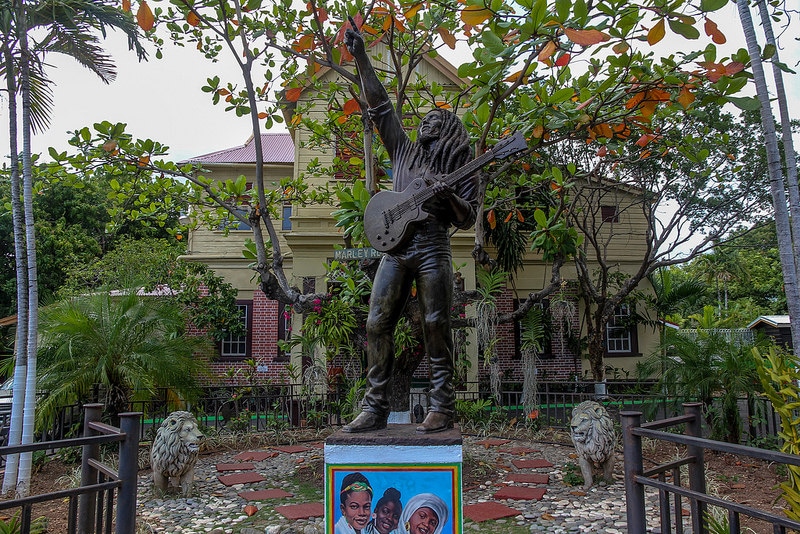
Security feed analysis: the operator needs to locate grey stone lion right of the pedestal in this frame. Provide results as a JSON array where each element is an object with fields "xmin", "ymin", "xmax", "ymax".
[{"xmin": 570, "ymin": 401, "xmax": 617, "ymax": 490}]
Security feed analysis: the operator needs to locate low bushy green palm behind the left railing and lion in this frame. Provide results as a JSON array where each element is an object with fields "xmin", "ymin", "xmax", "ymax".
[{"xmin": 37, "ymin": 290, "xmax": 205, "ymax": 430}]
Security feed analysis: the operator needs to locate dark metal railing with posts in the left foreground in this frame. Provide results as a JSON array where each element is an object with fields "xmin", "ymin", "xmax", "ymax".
[{"xmin": 0, "ymin": 404, "xmax": 141, "ymax": 534}]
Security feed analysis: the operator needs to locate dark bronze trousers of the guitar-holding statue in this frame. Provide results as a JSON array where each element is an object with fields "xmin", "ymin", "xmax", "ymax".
[{"xmin": 362, "ymin": 223, "xmax": 455, "ymax": 417}]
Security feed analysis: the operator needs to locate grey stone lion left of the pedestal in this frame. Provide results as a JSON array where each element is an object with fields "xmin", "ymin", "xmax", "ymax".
[{"xmin": 150, "ymin": 411, "xmax": 205, "ymax": 497}]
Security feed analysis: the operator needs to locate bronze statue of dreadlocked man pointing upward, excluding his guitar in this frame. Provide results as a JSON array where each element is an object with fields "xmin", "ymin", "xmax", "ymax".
[{"xmin": 342, "ymin": 21, "xmax": 478, "ymax": 434}]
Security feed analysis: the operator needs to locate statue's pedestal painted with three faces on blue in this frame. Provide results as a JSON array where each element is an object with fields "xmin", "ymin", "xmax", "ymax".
[{"xmin": 325, "ymin": 424, "xmax": 463, "ymax": 534}]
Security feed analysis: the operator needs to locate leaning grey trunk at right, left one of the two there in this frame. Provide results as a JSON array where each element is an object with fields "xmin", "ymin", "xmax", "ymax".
[{"xmin": 736, "ymin": 0, "xmax": 800, "ymax": 357}]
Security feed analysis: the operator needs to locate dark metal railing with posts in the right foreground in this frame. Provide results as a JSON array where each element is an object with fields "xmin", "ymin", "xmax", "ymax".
[{"xmin": 620, "ymin": 403, "xmax": 800, "ymax": 534}]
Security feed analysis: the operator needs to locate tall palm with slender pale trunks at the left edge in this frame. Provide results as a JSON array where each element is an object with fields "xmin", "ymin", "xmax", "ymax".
[{"xmin": 0, "ymin": 0, "xmax": 144, "ymax": 496}]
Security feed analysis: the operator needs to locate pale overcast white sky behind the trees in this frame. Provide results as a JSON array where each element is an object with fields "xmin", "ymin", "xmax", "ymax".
[{"xmin": 0, "ymin": 6, "xmax": 800, "ymax": 162}]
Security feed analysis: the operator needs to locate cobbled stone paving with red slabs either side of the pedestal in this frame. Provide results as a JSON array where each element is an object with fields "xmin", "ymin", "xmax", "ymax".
[{"xmin": 138, "ymin": 437, "xmax": 676, "ymax": 534}]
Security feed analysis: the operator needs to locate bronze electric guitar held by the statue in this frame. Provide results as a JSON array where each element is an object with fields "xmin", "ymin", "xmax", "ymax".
[{"xmin": 364, "ymin": 132, "xmax": 528, "ymax": 252}]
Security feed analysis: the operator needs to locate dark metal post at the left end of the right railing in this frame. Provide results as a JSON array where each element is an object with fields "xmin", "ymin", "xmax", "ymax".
[{"xmin": 619, "ymin": 411, "xmax": 647, "ymax": 534}]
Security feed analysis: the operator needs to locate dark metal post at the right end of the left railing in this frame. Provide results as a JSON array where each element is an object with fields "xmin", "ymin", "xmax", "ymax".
[{"xmin": 115, "ymin": 412, "xmax": 142, "ymax": 534}]
